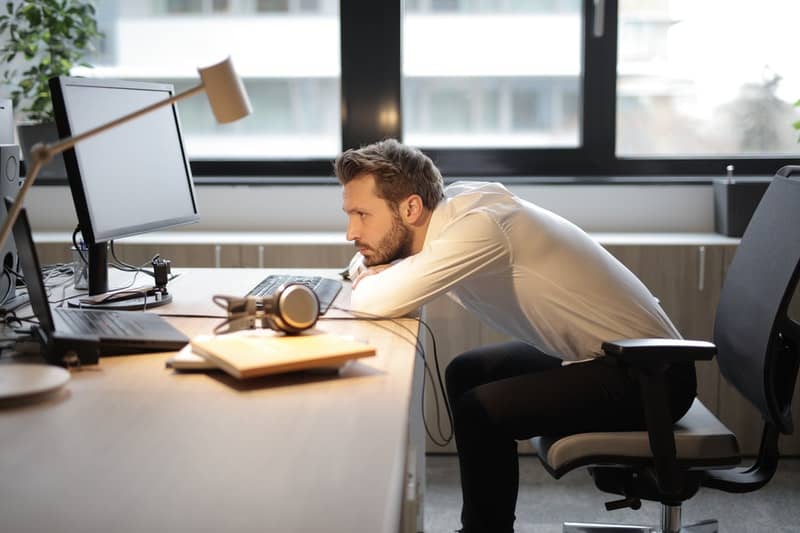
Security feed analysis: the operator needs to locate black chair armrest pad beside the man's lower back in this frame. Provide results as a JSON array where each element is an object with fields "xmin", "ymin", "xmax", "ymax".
[{"xmin": 602, "ymin": 339, "xmax": 717, "ymax": 366}]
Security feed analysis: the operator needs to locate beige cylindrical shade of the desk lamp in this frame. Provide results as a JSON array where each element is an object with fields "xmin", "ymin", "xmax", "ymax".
[{"xmin": 197, "ymin": 57, "xmax": 253, "ymax": 124}]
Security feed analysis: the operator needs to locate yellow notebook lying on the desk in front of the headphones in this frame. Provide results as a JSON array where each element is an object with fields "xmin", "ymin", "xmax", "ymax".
[{"xmin": 191, "ymin": 330, "xmax": 375, "ymax": 378}]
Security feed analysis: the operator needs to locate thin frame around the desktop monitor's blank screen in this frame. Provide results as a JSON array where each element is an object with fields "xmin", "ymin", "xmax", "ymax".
[{"xmin": 50, "ymin": 76, "xmax": 200, "ymax": 245}]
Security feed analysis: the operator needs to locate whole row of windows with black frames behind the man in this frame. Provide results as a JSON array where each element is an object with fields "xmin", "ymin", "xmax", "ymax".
[{"xmin": 29, "ymin": 0, "xmax": 800, "ymax": 181}]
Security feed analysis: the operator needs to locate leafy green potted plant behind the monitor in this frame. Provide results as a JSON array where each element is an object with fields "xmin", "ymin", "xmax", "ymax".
[{"xmin": 0, "ymin": 0, "xmax": 102, "ymax": 177}]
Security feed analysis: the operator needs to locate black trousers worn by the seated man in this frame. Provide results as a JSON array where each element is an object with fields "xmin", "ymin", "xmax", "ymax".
[{"xmin": 445, "ymin": 342, "xmax": 697, "ymax": 533}]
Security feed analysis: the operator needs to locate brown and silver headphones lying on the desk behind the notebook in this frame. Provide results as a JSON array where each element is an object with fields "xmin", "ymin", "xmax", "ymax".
[{"xmin": 217, "ymin": 283, "xmax": 319, "ymax": 335}]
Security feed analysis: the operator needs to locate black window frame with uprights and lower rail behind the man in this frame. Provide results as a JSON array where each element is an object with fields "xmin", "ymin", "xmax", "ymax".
[{"xmin": 61, "ymin": 0, "xmax": 799, "ymax": 184}]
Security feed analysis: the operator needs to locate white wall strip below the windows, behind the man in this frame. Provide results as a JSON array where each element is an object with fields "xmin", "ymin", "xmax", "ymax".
[{"xmin": 26, "ymin": 185, "xmax": 714, "ymax": 232}]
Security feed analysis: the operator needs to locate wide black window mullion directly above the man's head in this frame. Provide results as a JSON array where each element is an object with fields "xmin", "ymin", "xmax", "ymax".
[{"xmin": 340, "ymin": 0, "xmax": 402, "ymax": 150}]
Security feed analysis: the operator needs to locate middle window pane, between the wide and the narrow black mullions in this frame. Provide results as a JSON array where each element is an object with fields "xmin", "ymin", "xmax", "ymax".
[{"xmin": 402, "ymin": 0, "xmax": 582, "ymax": 148}]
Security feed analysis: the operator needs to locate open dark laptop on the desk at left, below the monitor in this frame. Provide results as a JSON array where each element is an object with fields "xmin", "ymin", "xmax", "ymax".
[{"xmin": 6, "ymin": 198, "xmax": 189, "ymax": 355}]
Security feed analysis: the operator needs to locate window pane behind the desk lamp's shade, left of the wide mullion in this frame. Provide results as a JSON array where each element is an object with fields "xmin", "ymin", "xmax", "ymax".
[{"xmin": 83, "ymin": 0, "xmax": 341, "ymax": 160}]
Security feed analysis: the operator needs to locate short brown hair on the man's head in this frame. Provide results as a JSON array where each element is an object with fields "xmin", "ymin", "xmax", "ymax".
[{"xmin": 334, "ymin": 139, "xmax": 444, "ymax": 210}]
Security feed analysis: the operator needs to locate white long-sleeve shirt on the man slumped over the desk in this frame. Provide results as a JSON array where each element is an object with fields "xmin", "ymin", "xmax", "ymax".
[{"xmin": 351, "ymin": 182, "xmax": 680, "ymax": 360}]
